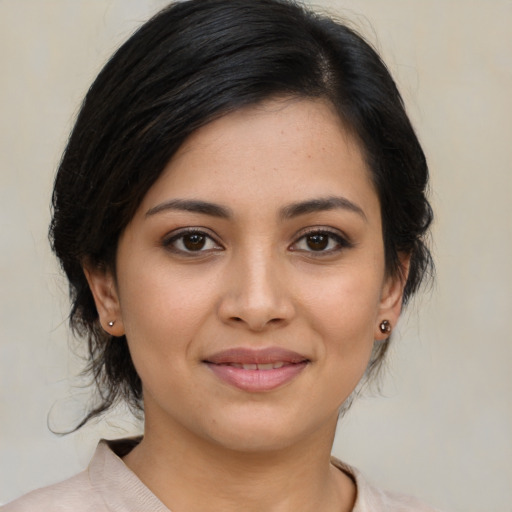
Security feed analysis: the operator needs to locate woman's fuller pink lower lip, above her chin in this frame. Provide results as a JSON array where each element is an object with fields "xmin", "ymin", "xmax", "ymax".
[{"xmin": 207, "ymin": 362, "xmax": 307, "ymax": 393}]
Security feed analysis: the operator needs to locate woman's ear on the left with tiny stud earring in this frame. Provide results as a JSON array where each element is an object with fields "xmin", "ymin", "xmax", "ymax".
[{"xmin": 83, "ymin": 263, "xmax": 124, "ymax": 336}]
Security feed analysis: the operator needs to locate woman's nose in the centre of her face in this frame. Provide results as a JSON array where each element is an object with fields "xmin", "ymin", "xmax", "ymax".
[{"xmin": 218, "ymin": 249, "xmax": 295, "ymax": 332}]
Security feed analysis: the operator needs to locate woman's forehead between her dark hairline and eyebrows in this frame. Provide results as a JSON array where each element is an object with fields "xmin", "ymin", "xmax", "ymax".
[{"xmin": 138, "ymin": 99, "xmax": 378, "ymax": 219}]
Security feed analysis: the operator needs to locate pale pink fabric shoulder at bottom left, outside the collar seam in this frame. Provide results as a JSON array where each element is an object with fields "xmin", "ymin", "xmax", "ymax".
[{"xmin": 0, "ymin": 471, "xmax": 106, "ymax": 512}]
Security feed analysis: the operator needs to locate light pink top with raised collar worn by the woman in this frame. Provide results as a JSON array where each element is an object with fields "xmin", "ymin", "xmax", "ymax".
[{"xmin": 0, "ymin": 440, "xmax": 436, "ymax": 512}]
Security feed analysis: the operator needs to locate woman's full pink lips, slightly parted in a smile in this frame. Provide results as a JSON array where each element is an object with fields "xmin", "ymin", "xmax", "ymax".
[{"xmin": 204, "ymin": 347, "xmax": 309, "ymax": 393}]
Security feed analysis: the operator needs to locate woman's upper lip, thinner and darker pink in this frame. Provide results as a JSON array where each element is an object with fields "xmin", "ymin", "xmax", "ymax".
[{"xmin": 204, "ymin": 347, "xmax": 309, "ymax": 364}]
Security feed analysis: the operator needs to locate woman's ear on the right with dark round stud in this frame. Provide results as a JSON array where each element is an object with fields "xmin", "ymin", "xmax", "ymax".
[{"xmin": 375, "ymin": 254, "xmax": 411, "ymax": 341}]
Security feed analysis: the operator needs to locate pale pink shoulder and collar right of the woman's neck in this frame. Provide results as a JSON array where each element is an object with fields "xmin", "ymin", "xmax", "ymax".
[{"xmin": 332, "ymin": 458, "xmax": 440, "ymax": 512}]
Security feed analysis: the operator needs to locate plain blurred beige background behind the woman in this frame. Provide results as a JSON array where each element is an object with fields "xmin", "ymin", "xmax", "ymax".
[{"xmin": 0, "ymin": 0, "xmax": 512, "ymax": 512}]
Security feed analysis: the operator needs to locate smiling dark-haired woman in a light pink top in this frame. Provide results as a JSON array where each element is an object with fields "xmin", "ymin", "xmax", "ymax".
[{"xmin": 5, "ymin": 0, "xmax": 432, "ymax": 512}]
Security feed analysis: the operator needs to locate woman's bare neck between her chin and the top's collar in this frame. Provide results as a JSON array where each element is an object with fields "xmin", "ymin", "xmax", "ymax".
[{"xmin": 124, "ymin": 412, "xmax": 355, "ymax": 512}]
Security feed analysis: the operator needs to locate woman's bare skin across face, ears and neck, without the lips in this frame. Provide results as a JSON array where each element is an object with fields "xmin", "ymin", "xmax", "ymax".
[{"xmin": 85, "ymin": 99, "xmax": 403, "ymax": 512}]
